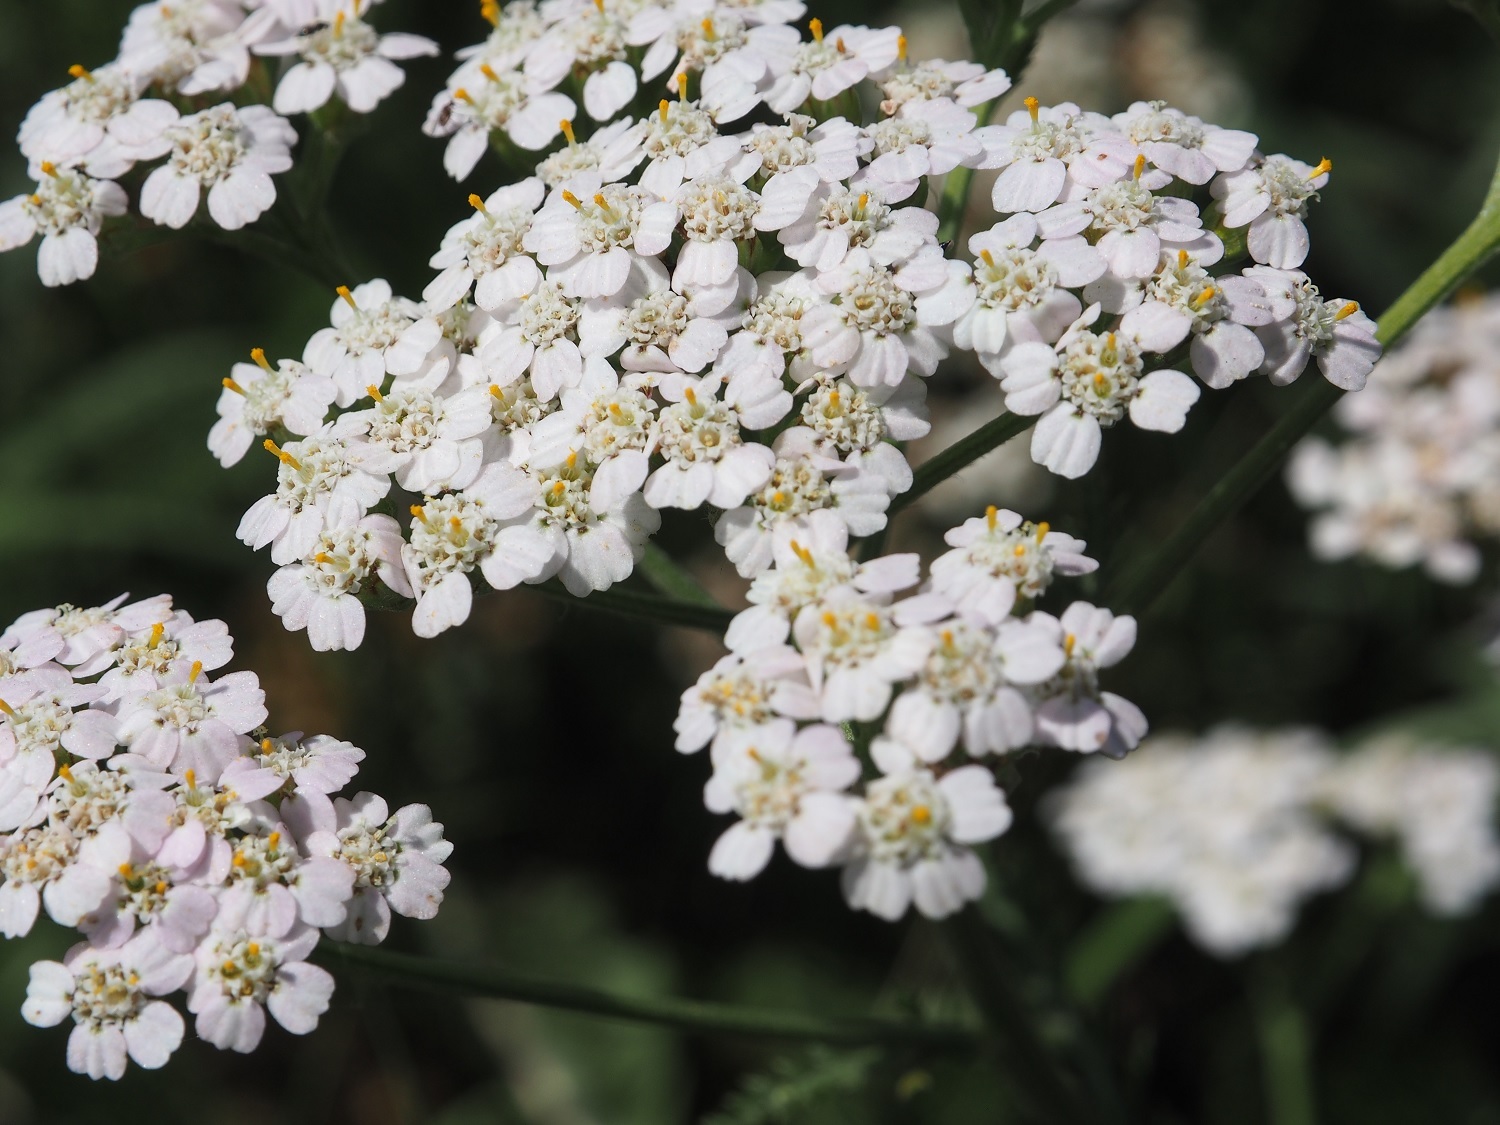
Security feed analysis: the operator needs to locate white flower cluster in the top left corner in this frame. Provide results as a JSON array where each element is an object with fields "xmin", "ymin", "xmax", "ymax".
[{"xmin": 0, "ymin": 0, "xmax": 438, "ymax": 285}]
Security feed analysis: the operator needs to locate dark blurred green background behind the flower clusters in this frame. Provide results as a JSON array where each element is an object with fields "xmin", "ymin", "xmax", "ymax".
[{"xmin": 0, "ymin": 0, "xmax": 1500, "ymax": 1125}]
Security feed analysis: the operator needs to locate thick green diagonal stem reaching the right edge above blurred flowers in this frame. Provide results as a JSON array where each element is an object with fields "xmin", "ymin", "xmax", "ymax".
[{"xmin": 1104, "ymin": 146, "xmax": 1500, "ymax": 614}]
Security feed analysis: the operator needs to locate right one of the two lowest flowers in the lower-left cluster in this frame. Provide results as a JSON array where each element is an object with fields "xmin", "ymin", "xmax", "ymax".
[{"xmin": 188, "ymin": 924, "xmax": 333, "ymax": 1055}]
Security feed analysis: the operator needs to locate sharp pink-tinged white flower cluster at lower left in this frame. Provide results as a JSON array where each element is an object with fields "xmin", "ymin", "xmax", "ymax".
[{"xmin": 0, "ymin": 596, "xmax": 452, "ymax": 1079}]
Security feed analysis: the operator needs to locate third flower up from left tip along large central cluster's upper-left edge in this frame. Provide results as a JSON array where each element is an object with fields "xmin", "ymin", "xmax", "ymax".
[{"xmin": 422, "ymin": 177, "xmax": 546, "ymax": 312}]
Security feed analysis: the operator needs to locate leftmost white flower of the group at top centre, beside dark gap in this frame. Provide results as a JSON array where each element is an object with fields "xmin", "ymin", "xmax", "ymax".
[{"xmin": 422, "ymin": 62, "xmax": 578, "ymax": 180}]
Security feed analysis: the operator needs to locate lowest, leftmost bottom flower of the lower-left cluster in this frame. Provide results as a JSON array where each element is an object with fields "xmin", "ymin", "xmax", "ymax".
[{"xmin": 21, "ymin": 935, "xmax": 194, "ymax": 1080}]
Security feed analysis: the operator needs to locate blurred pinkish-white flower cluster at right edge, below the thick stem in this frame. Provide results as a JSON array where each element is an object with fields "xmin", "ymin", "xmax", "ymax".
[{"xmin": 1287, "ymin": 297, "xmax": 1500, "ymax": 584}]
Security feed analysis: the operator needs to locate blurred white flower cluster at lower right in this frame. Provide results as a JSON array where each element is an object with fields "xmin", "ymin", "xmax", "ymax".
[{"xmin": 1052, "ymin": 726, "xmax": 1500, "ymax": 957}]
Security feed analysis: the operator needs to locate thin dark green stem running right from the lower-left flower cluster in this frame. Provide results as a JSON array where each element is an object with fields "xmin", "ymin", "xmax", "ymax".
[{"xmin": 315, "ymin": 941, "xmax": 978, "ymax": 1049}]
